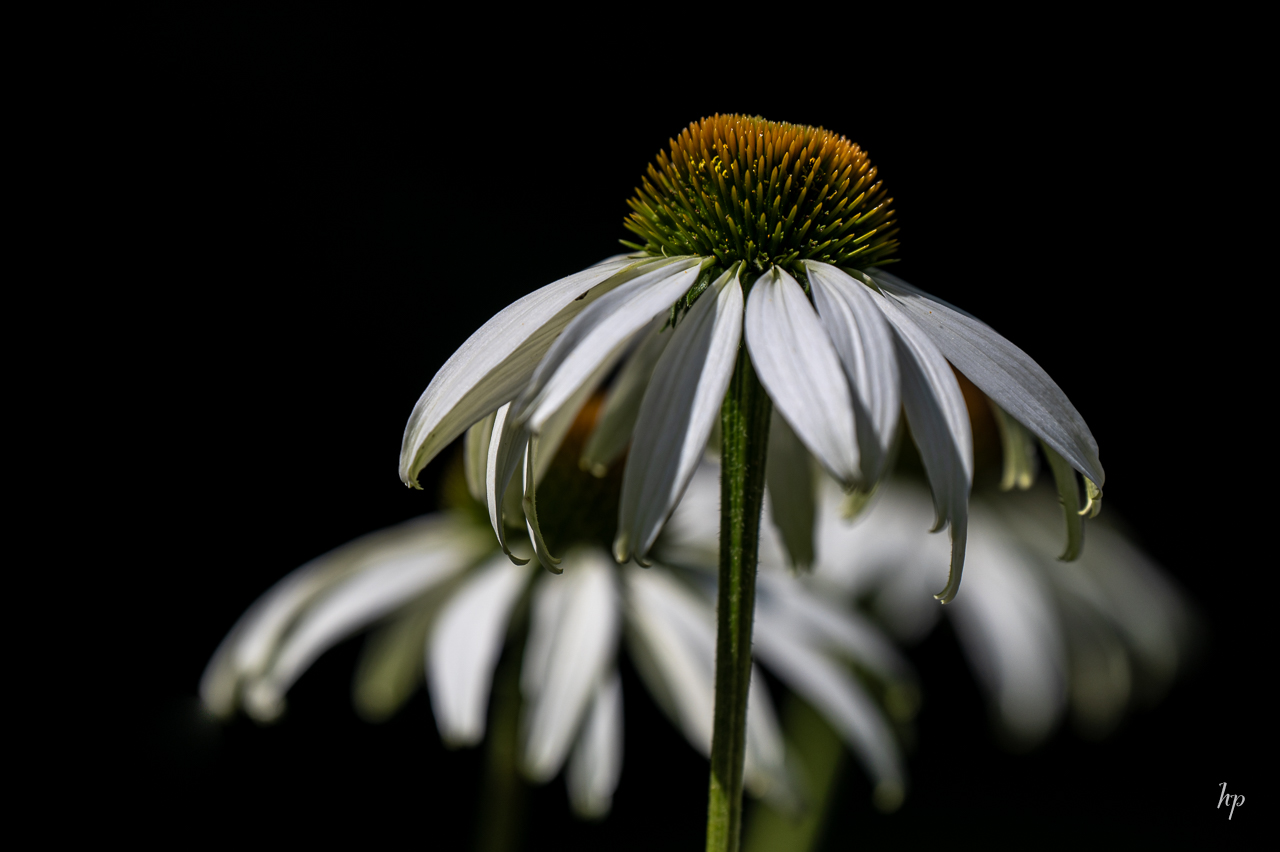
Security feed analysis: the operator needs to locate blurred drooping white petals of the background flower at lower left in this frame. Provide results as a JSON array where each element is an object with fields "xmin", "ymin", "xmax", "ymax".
[{"xmin": 201, "ymin": 472, "xmax": 911, "ymax": 816}]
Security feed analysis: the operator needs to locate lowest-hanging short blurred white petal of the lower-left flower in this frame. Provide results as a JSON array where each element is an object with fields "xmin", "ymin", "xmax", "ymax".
[{"xmin": 564, "ymin": 672, "xmax": 622, "ymax": 819}]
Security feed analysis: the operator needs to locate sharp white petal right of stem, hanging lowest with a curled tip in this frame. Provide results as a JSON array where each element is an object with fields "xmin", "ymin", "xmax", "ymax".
[{"xmin": 876, "ymin": 294, "xmax": 973, "ymax": 604}]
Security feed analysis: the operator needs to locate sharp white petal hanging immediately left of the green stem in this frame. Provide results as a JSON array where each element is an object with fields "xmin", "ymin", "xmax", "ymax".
[{"xmin": 613, "ymin": 270, "xmax": 742, "ymax": 562}]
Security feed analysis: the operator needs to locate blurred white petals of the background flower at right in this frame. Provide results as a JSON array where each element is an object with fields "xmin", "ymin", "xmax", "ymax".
[{"xmin": 716, "ymin": 477, "xmax": 1198, "ymax": 746}]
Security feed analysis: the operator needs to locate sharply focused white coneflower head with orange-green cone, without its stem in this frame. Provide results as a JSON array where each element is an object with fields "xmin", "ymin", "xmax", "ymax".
[{"xmin": 401, "ymin": 115, "xmax": 1103, "ymax": 603}]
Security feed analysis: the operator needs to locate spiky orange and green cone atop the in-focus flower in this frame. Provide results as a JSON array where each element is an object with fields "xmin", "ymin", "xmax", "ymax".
[{"xmin": 623, "ymin": 115, "xmax": 897, "ymax": 272}]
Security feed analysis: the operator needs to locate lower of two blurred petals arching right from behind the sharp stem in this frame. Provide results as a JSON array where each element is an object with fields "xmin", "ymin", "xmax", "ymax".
[{"xmin": 755, "ymin": 613, "xmax": 905, "ymax": 797}]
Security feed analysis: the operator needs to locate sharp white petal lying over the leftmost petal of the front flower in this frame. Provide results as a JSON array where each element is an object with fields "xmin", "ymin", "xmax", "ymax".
[{"xmin": 518, "ymin": 257, "xmax": 701, "ymax": 432}]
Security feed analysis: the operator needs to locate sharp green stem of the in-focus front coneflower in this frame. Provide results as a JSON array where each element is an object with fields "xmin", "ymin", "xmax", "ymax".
[{"xmin": 707, "ymin": 344, "xmax": 773, "ymax": 852}]
